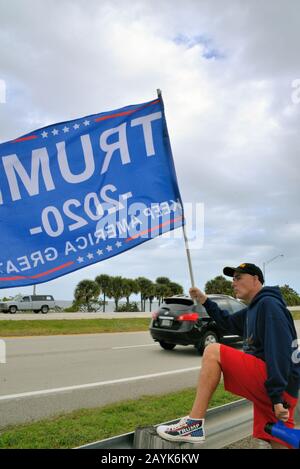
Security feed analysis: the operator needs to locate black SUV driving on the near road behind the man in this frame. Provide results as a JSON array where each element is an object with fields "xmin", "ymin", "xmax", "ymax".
[{"xmin": 150, "ymin": 295, "xmax": 245, "ymax": 353}]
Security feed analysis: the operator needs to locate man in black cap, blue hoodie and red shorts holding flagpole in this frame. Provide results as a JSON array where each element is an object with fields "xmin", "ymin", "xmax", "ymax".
[{"xmin": 157, "ymin": 263, "xmax": 300, "ymax": 449}]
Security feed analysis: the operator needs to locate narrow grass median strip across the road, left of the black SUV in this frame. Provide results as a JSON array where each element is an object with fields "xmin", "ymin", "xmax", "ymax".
[{"xmin": 0, "ymin": 318, "xmax": 150, "ymax": 337}]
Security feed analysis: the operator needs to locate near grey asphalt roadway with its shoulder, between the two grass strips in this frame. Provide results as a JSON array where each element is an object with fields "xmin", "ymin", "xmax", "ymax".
[{"xmin": 0, "ymin": 332, "xmax": 201, "ymax": 427}]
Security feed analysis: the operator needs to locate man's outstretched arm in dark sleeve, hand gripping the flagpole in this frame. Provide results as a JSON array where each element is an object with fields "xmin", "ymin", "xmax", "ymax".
[{"xmin": 189, "ymin": 287, "xmax": 247, "ymax": 336}]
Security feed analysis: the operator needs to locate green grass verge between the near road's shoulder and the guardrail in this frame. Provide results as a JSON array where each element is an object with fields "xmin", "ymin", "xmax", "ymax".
[{"xmin": 0, "ymin": 384, "xmax": 239, "ymax": 449}]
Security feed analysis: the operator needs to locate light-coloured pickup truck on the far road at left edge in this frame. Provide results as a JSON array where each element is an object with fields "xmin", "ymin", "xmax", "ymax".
[{"xmin": 0, "ymin": 295, "xmax": 55, "ymax": 314}]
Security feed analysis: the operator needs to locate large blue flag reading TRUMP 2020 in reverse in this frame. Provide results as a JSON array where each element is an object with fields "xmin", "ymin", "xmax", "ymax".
[{"xmin": 0, "ymin": 98, "xmax": 184, "ymax": 288}]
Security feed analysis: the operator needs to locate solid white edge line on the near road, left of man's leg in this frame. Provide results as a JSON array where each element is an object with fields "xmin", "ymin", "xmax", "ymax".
[{"xmin": 0, "ymin": 366, "xmax": 201, "ymax": 402}]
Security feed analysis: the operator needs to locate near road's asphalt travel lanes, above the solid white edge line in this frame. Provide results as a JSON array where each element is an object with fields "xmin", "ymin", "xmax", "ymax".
[{"xmin": 0, "ymin": 332, "xmax": 201, "ymax": 396}]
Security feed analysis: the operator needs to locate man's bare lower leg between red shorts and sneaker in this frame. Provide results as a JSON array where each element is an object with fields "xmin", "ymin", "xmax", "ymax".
[{"xmin": 190, "ymin": 344, "xmax": 222, "ymax": 419}]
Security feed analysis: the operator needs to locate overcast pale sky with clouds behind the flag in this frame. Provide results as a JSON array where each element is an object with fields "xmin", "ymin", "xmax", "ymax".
[{"xmin": 0, "ymin": 0, "xmax": 300, "ymax": 299}]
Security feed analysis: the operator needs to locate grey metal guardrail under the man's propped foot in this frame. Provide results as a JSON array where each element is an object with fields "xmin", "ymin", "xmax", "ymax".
[{"xmin": 75, "ymin": 399, "xmax": 252, "ymax": 449}]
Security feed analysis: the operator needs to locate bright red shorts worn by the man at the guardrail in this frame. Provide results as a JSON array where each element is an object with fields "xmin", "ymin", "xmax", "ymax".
[{"xmin": 220, "ymin": 345, "xmax": 298, "ymax": 448}]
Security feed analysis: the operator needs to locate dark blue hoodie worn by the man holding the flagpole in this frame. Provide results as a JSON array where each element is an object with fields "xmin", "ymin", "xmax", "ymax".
[{"xmin": 203, "ymin": 287, "xmax": 300, "ymax": 404}]
